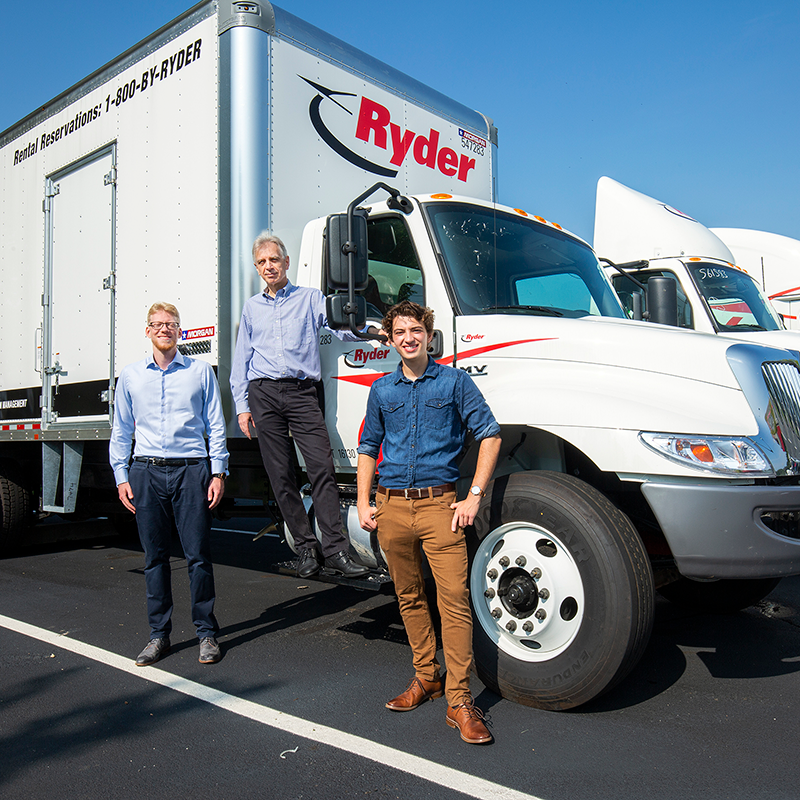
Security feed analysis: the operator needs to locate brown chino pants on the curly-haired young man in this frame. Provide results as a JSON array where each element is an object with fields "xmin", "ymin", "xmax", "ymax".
[{"xmin": 375, "ymin": 492, "xmax": 472, "ymax": 706}]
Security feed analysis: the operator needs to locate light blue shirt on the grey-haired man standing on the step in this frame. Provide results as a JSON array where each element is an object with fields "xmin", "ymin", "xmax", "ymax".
[{"xmin": 231, "ymin": 281, "xmax": 359, "ymax": 415}]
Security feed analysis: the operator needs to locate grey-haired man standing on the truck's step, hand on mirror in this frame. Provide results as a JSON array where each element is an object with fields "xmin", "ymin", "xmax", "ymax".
[{"xmin": 231, "ymin": 233, "xmax": 369, "ymax": 578}]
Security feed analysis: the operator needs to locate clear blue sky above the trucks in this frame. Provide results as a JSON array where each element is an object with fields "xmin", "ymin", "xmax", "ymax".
[{"xmin": 0, "ymin": 0, "xmax": 800, "ymax": 241}]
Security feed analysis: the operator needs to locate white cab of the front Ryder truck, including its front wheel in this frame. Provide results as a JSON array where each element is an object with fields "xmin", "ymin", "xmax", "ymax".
[{"xmin": 293, "ymin": 186, "xmax": 800, "ymax": 709}]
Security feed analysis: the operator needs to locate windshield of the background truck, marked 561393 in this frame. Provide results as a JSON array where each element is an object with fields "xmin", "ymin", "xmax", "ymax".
[{"xmin": 687, "ymin": 262, "xmax": 783, "ymax": 331}]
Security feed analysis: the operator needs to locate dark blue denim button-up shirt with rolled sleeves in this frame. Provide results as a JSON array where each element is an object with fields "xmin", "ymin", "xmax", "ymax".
[{"xmin": 358, "ymin": 357, "xmax": 500, "ymax": 489}]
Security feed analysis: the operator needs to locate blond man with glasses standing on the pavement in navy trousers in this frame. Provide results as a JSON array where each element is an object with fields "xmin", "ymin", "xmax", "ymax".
[{"xmin": 109, "ymin": 303, "xmax": 228, "ymax": 667}]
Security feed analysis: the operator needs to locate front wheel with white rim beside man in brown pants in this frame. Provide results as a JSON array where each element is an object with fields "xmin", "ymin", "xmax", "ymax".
[{"xmin": 470, "ymin": 472, "xmax": 654, "ymax": 711}]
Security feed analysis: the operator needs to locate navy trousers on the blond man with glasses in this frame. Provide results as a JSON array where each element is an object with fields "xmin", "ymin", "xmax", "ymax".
[{"xmin": 128, "ymin": 459, "xmax": 219, "ymax": 639}]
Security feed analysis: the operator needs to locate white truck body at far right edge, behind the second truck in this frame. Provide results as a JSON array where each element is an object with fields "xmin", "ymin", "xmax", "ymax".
[{"xmin": 710, "ymin": 228, "xmax": 800, "ymax": 330}]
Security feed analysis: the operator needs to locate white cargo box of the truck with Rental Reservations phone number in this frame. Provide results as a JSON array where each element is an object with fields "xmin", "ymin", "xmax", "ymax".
[{"xmin": 0, "ymin": 2, "xmax": 497, "ymax": 512}]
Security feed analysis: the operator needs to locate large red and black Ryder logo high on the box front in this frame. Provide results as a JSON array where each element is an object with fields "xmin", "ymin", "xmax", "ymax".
[{"xmin": 299, "ymin": 75, "xmax": 478, "ymax": 183}]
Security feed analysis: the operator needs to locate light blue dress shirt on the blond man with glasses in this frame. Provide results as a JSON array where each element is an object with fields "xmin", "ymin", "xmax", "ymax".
[{"xmin": 108, "ymin": 352, "xmax": 228, "ymax": 485}]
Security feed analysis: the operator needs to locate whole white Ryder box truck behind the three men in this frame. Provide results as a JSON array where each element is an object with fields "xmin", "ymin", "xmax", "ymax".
[{"xmin": 0, "ymin": 3, "xmax": 800, "ymax": 709}]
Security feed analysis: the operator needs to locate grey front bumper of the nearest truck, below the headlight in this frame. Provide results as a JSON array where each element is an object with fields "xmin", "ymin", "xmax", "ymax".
[{"xmin": 642, "ymin": 482, "xmax": 800, "ymax": 578}]
